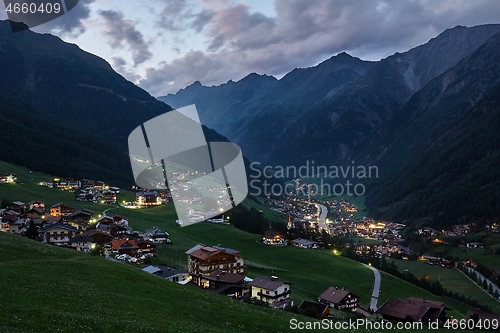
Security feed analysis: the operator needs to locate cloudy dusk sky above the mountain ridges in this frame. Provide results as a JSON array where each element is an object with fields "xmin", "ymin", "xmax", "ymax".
[{"xmin": 0, "ymin": 0, "xmax": 500, "ymax": 96}]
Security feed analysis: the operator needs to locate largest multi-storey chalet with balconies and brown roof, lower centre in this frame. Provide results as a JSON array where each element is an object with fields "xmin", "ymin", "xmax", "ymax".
[{"xmin": 186, "ymin": 244, "xmax": 245, "ymax": 276}]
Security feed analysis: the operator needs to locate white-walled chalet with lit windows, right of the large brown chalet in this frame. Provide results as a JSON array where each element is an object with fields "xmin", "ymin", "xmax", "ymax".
[{"xmin": 249, "ymin": 276, "xmax": 293, "ymax": 309}]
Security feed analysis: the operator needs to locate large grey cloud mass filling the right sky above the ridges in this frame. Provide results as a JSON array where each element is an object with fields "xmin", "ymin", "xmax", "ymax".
[{"xmin": 141, "ymin": 0, "xmax": 500, "ymax": 95}]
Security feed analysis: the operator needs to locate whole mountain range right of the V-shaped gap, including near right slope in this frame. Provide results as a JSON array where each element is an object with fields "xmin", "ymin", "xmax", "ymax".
[{"xmin": 160, "ymin": 24, "xmax": 500, "ymax": 224}]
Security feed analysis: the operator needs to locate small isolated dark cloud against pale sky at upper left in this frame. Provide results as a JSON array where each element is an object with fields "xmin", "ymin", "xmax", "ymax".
[{"xmin": 99, "ymin": 10, "xmax": 152, "ymax": 65}]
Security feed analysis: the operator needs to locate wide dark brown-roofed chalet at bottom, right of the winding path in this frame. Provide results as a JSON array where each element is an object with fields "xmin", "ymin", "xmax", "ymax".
[{"xmin": 375, "ymin": 297, "xmax": 447, "ymax": 322}]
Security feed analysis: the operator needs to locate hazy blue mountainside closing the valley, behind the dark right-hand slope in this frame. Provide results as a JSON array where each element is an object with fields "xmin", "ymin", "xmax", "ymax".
[{"xmin": 161, "ymin": 25, "xmax": 500, "ymax": 165}]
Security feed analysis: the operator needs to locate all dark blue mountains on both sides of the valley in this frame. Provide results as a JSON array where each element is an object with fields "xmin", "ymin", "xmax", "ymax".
[{"xmin": 0, "ymin": 21, "xmax": 500, "ymax": 224}]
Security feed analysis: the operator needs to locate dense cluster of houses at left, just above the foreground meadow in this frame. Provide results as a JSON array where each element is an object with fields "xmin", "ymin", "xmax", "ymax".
[{"xmin": 0, "ymin": 201, "xmax": 170, "ymax": 262}]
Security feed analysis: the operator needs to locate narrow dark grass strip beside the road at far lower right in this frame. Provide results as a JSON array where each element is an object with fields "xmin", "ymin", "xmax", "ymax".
[{"xmin": 394, "ymin": 260, "xmax": 500, "ymax": 313}]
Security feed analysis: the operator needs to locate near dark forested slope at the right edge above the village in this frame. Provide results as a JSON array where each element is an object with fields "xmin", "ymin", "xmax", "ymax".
[{"xmin": 367, "ymin": 33, "xmax": 500, "ymax": 223}]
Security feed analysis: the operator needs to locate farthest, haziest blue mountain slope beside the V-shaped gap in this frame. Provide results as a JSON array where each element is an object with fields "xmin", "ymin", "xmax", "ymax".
[{"xmin": 160, "ymin": 53, "xmax": 372, "ymax": 161}]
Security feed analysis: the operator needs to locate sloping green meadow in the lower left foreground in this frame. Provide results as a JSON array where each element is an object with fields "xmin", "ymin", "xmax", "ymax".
[{"xmin": 0, "ymin": 234, "xmax": 301, "ymax": 332}]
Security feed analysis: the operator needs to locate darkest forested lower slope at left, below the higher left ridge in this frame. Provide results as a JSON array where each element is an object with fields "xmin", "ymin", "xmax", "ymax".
[{"xmin": 0, "ymin": 94, "xmax": 133, "ymax": 186}]
